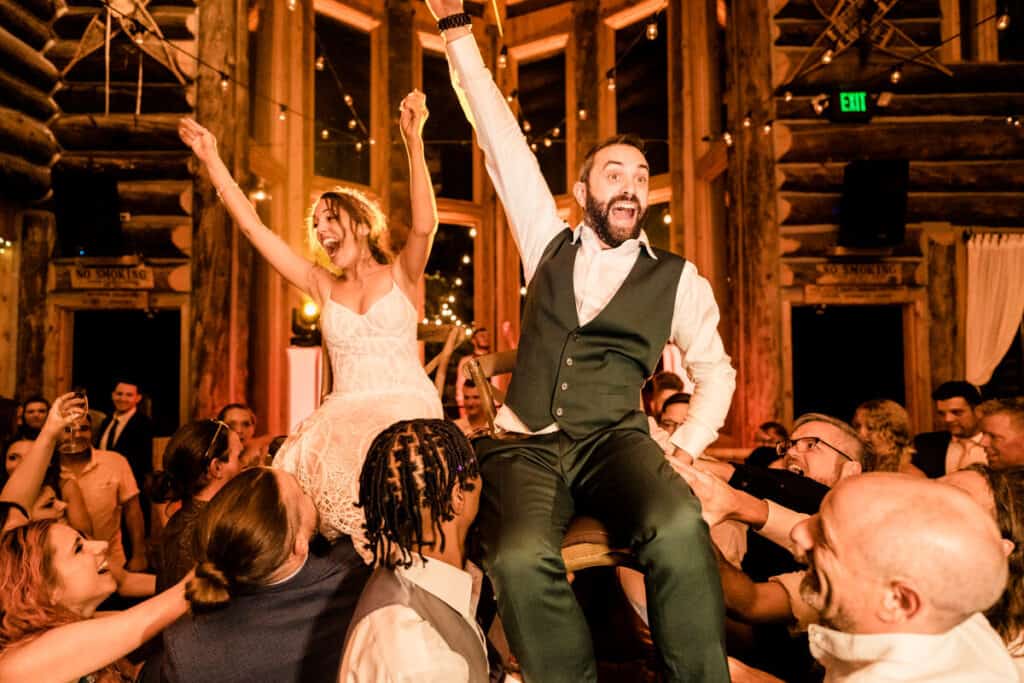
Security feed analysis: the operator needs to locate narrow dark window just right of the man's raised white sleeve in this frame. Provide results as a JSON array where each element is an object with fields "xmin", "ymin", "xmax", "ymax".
[{"xmin": 519, "ymin": 52, "xmax": 567, "ymax": 195}]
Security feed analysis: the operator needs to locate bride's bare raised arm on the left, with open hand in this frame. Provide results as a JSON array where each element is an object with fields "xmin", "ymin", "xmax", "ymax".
[{"xmin": 178, "ymin": 119, "xmax": 322, "ymax": 304}]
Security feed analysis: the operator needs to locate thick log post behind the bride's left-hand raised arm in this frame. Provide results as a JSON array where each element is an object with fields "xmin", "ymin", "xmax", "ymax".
[{"xmin": 188, "ymin": 0, "xmax": 249, "ymax": 418}]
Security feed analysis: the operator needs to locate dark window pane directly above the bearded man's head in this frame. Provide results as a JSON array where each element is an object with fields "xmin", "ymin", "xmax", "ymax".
[{"xmin": 614, "ymin": 11, "xmax": 669, "ymax": 175}]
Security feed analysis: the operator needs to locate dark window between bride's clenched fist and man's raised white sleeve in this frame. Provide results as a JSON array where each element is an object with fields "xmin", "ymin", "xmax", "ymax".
[{"xmin": 423, "ymin": 50, "xmax": 473, "ymax": 201}]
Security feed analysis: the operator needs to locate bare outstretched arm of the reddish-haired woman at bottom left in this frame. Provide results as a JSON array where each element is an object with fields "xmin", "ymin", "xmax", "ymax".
[{"xmin": 0, "ymin": 572, "xmax": 191, "ymax": 683}]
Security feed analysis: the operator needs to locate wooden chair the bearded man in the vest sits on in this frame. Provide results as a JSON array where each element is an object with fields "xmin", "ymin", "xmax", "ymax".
[{"xmin": 463, "ymin": 350, "xmax": 633, "ymax": 573}]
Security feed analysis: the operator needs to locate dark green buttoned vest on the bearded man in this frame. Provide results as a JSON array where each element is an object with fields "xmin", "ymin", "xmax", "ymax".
[{"xmin": 506, "ymin": 228, "xmax": 686, "ymax": 439}]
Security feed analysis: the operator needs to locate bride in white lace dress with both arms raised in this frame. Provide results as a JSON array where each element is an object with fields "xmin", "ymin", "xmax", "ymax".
[{"xmin": 178, "ymin": 90, "xmax": 443, "ymax": 558}]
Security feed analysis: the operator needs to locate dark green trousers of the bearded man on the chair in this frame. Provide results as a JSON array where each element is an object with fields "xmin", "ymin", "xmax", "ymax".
[{"xmin": 475, "ymin": 414, "xmax": 729, "ymax": 683}]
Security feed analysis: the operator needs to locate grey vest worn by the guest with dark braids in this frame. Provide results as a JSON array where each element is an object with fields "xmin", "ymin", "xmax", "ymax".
[{"xmin": 345, "ymin": 567, "xmax": 489, "ymax": 683}]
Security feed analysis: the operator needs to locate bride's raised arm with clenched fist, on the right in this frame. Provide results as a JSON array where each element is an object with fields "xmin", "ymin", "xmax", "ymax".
[{"xmin": 398, "ymin": 90, "xmax": 437, "ymax": 290}]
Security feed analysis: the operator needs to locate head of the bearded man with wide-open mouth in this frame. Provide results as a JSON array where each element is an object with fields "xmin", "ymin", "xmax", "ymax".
[{"xmin": 573, "ymin": 144, "xmax": 650, "ymax": 248}]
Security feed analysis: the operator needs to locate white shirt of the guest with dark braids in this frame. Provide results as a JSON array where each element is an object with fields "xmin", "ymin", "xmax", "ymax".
[{"xmin": 338, "ymin": 558, "xmax": 486, "ymax": 683}]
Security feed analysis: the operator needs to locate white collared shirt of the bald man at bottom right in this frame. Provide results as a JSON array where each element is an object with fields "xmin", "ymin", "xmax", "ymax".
[{"xmin": 808, "ymin": 614, "xmax": 1020, "ymax": 683}]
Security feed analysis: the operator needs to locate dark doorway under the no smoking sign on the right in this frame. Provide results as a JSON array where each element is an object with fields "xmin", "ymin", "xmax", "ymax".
[{"xmin": 793, "ymin": 304, "xmax": 906, "ymax": 420}]
